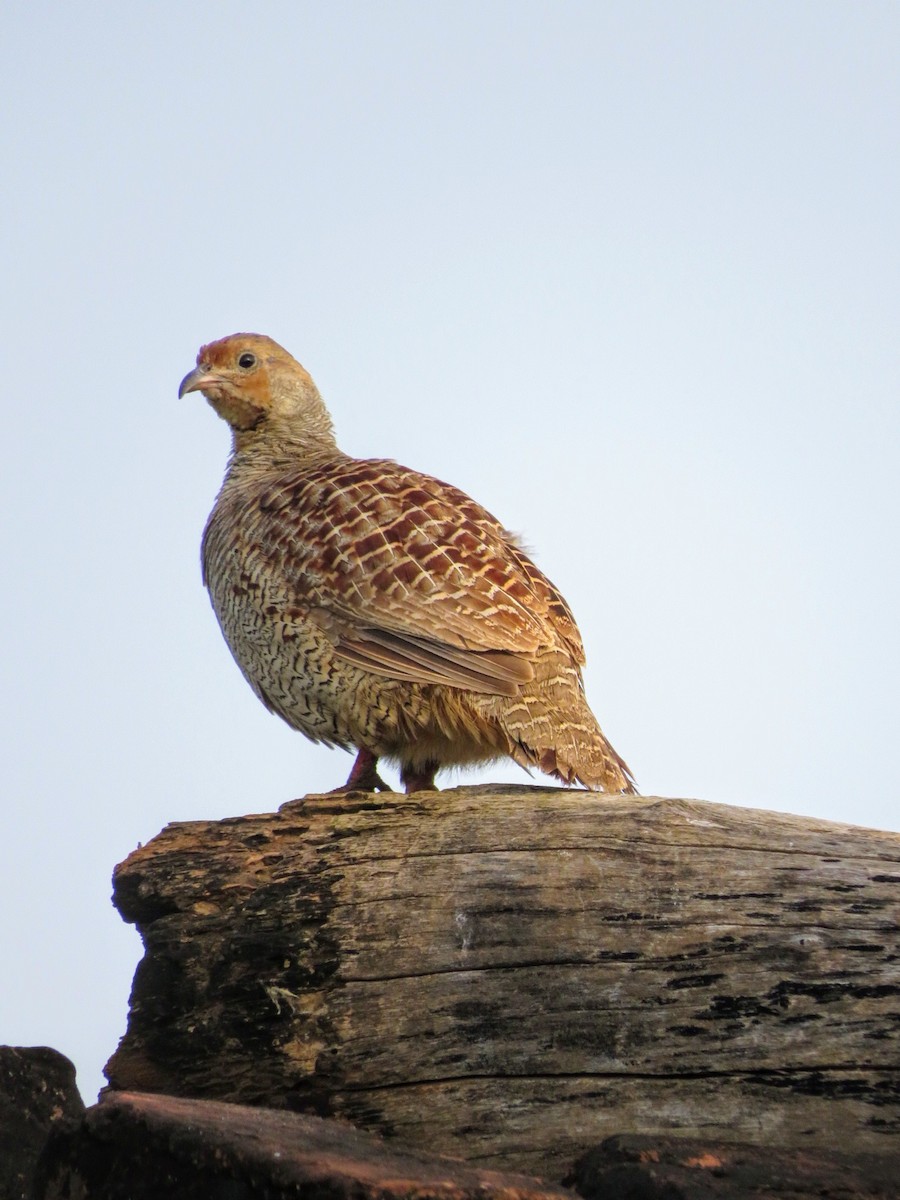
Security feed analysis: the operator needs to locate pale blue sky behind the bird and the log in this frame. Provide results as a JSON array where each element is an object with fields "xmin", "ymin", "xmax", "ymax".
[{"xmin": 0, "ymin": 0, "xmax": 900, "ymax": 1098}]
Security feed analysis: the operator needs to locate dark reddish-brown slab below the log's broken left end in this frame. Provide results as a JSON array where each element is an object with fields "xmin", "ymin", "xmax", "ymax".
[{"xmin": 35, "ymin": 1092, "xmax": 577, "ymax": 1200}]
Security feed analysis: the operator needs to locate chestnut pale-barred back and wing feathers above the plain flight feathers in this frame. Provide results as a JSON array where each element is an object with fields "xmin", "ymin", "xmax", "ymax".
[{"xmin": 259, "ymin": 458, "xmax": 564, "ymax": 654}]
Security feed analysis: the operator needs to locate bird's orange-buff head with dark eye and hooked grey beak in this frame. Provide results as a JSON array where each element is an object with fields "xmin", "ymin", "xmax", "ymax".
[{"xmin": 178, "ymin": 334, "xmax": 334, "ymax": 445}]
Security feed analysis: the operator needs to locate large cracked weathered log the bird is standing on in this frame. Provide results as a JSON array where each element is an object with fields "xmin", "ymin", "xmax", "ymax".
[{"xmin": 107, "ymin": 787, "xmax": 900, "ymax": 1178}]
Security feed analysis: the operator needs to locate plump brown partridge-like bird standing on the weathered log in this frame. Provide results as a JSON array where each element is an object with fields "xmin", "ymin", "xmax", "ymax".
[{"xmin": 179, "ymin": 334, "xmax": 636, "ymax": 793}]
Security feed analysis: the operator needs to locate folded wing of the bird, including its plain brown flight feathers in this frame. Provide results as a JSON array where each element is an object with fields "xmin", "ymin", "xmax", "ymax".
[{"xmin": 259, "ymin": 460, "xmax": 583, "ymax": 695}]
